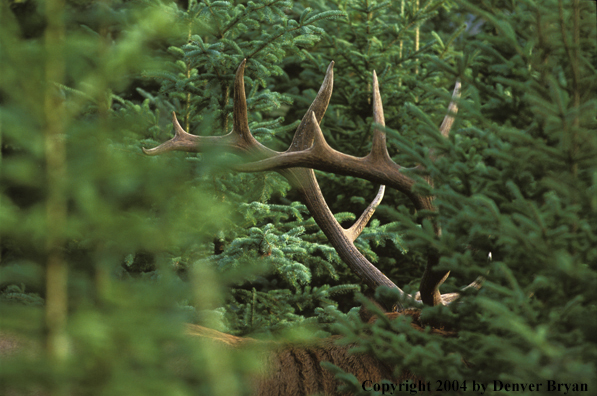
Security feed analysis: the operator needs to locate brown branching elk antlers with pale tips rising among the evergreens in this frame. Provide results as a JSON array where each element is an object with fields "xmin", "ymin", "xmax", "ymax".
[{"xmin": 143, "ymin": 59, "xmax": 460, "ymax": 308}]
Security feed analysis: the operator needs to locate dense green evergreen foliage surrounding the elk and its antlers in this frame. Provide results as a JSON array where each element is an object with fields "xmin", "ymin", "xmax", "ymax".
[{"xmin": 0, "ymin": 0, "xmax": 597, "ymax": 396}]
